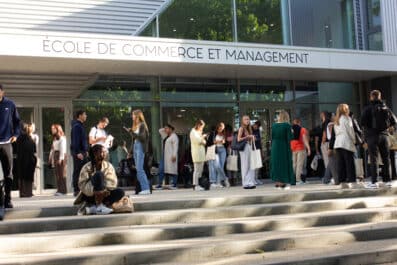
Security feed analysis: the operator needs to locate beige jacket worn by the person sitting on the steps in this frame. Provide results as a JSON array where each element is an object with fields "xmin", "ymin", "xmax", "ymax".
[{"xmin": 79, "ymin": 161, "xmax": 117, "ymax": 196}]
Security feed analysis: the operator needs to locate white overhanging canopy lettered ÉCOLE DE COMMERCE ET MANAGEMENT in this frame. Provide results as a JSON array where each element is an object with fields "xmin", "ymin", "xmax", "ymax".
[{"xmin": 0, "ymin": 31, "xmax": 397, "ymax": 97}]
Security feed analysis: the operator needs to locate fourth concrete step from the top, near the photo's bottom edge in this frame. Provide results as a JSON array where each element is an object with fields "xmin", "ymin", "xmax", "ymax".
[{"xmin": 0, "ymin": 222, "xmax": 397, "ymax": 265}]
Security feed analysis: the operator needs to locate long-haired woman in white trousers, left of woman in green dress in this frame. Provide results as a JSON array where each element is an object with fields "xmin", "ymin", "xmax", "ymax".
[{"xmin": 237, "ymin": 115, "xmax": 256, "ymax": 189}]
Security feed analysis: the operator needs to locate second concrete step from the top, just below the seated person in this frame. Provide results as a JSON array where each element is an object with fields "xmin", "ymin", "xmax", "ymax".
[{"xmin": 0, "ymin": 196, "xmax": 397, "ymax": 234}]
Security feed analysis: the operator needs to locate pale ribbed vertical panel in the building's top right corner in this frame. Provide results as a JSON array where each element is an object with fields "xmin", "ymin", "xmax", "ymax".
[{"xmin": 380, "ymin": 0, "xmax": 397, "ymax": 53}]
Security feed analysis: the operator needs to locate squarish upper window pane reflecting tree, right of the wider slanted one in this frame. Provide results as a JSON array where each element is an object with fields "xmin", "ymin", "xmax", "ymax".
[{"xmin": 237, "ymin": 0, "xmax": 283, "ymax": 44}]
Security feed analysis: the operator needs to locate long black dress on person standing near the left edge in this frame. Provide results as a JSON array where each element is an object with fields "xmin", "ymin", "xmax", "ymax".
[{"xmin": 15, "ymin": 134, "xmax": 37, "ymax": 197}]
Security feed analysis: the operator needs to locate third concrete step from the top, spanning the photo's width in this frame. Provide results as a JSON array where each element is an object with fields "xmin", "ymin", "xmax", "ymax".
[{"xmin": 0, "ymin": 207, "xmax": 397, "ymax": 253}]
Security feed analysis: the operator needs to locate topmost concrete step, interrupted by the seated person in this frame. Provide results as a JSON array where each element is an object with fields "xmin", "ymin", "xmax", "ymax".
[{"xmin": 5, "ymin": 188, "xmax": 397, "ymax": 220}]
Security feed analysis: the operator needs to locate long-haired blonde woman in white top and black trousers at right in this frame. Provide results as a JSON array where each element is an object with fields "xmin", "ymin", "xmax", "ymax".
[{"xmin": 334, "ymin": 104, "xmax": 356, "ymax": 188}]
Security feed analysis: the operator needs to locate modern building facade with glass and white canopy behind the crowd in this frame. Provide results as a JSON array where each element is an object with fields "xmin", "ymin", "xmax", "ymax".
[{"xmin": 0, "ymin": 0, "xmax": 397, "ymax": 190}]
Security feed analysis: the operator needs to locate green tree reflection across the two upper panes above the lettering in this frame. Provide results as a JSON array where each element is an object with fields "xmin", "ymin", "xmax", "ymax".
[{"xmin": 160, "ymin": 0, "xmax": 282, "ymax": 44}]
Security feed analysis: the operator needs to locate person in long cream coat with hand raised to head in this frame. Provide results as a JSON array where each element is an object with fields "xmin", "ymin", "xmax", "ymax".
[{"xmin": 156, "ymin": 124, "xmax": 179, "ymax": 189}]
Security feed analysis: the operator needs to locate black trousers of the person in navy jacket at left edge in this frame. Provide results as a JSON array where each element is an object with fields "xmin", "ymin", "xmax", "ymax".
[{"xmin": 0, "ymin": 143, "xmax": 13, "ymax": 202}]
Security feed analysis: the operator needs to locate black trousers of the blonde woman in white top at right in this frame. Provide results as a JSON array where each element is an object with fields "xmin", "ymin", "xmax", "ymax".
[{"xmin": 335, "ymin": 148, "xmax": 356, "ymax": 183}]
